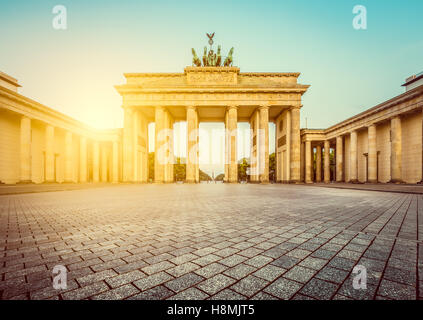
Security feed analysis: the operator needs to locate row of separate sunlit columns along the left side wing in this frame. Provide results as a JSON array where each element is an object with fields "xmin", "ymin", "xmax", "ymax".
[{"xmin": 19, "ymin": 116, "xmax": 119, "ymax": 183}]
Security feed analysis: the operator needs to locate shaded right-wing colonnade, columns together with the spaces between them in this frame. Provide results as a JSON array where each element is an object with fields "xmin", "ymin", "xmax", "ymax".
[{"xmin": 303, "ymin": 115, "xmax": 403, "ymax": 183}]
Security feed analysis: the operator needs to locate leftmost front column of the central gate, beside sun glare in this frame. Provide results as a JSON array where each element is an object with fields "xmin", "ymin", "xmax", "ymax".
[{"xmin": 123, "ymin": 107, "xmax": 134, "ymax": 182}]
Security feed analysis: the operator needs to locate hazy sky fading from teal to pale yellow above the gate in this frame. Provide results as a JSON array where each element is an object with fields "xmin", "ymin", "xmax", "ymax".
[{"xmin": 0, "ymin": 0, "xmax": 423, "ymax": 174}]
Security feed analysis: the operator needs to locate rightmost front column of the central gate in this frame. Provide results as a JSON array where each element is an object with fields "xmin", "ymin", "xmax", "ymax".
[{"xmin": 290, "ymin": 107, "xmax": 301, "ymax": 183}]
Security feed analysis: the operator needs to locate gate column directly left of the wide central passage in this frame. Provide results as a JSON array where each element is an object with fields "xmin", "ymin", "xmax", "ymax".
[{"xmin": 186, "ymin": 106, "xmax": 198, "ymax": 183}]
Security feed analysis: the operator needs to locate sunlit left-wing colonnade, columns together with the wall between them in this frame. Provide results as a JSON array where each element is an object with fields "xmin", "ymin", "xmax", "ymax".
[{"xmin": 19, "ymin": 116, "xmax": 119, "ymax": 183}]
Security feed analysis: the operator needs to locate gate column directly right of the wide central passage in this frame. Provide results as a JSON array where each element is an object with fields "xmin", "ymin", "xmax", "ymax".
[{"xmin": 227, "ymin": 106, "xmax": 238, "ymax": 183}]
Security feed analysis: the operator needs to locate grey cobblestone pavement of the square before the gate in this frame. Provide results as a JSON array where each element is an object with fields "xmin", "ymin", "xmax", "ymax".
[{"xmin": 0, "ymin": 185, "xmax": 423, "ymax": 299}]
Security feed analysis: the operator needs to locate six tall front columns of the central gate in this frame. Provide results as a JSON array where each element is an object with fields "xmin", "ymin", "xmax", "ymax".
[{"xmin": 123, "ymin": 105, "xmax": 300, "ymax": 183}]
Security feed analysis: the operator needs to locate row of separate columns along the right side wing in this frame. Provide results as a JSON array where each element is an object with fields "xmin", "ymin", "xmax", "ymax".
[{"xmin": 305, "ymin": 116, "xmax": 402, "ymax": 183}]
